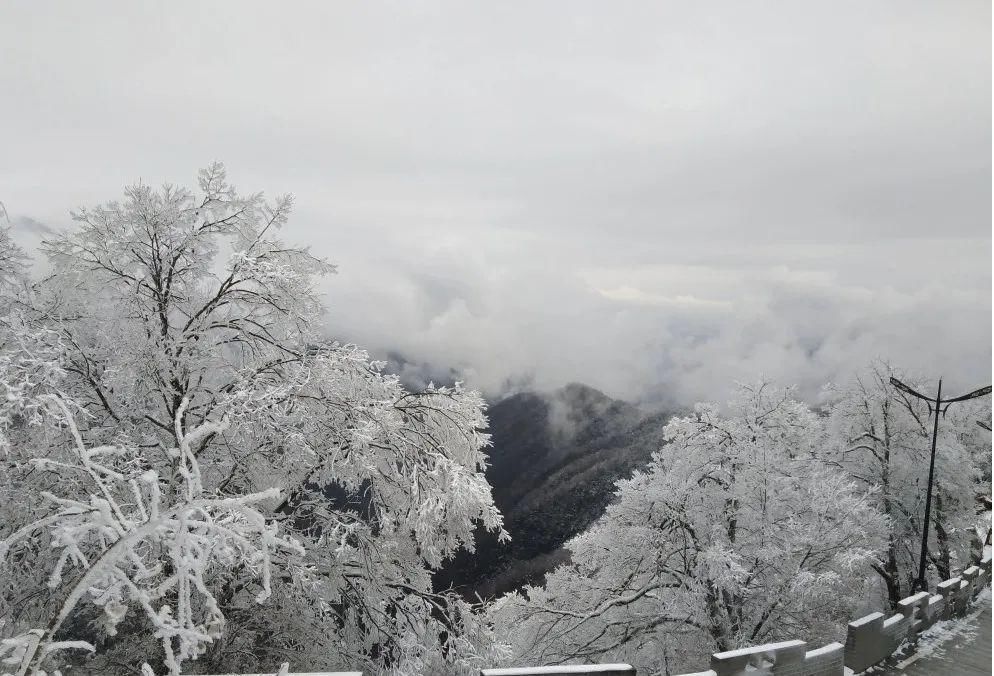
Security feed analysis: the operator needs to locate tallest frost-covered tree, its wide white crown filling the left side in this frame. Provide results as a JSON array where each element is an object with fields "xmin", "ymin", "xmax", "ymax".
[{"xmin": 0, "ymin": 165, "xmax": 501, "ymax": 673}]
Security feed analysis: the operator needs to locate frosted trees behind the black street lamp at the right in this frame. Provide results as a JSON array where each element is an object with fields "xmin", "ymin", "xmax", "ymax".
[{"xmin": 830, "ymin": 363, "xmax": 991, "ymax": 603}]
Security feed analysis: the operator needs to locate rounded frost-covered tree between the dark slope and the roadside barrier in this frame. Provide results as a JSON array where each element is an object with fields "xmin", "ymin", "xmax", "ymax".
[{"xmin": 492, "ymin": 384, "xmax": 886, "ymax": 673}]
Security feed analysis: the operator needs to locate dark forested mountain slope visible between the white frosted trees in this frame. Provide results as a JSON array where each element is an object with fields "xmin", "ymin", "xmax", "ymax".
[{"xmin": 435, "ymin": 384, "xmax": 670, "ymax": 596}]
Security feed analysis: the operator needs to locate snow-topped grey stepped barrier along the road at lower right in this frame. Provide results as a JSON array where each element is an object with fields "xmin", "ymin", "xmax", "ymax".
[{"xmin": 672, "ymin": 553, "xmax": 991, "ymax": 676}]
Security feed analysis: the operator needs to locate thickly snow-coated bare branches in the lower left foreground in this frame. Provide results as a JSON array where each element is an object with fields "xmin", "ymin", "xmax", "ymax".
[{"xmin": 0, "ymin": 382, "xmax": 302, "ymax": 674}]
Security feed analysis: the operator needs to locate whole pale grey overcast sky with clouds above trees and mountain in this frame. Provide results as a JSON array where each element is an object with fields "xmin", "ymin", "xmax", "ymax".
[{"xmin": 0, "ymin": 0, "xmax": 991, "ymax": 404}]
